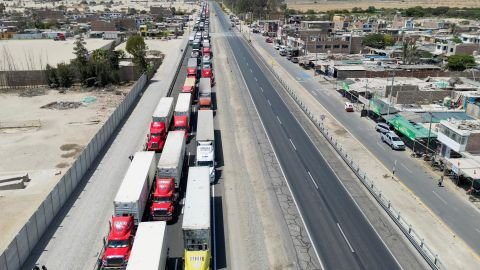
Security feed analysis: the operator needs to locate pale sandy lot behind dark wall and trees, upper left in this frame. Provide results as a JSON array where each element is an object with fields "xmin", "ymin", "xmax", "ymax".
[{"xmin": 0, "ymin": 38, "xmax": 112, "ymax": 71}]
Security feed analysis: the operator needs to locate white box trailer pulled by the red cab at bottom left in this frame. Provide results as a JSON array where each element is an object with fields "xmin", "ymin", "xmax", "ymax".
[{"xmin": 113, "ymin": 151, "xmax": 156, "ymax": 225}]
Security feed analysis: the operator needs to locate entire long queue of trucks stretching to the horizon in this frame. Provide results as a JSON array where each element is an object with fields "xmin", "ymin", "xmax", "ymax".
[{"xmin": 98, "ymin": 2, "xmax": 215, "ymax": 270}]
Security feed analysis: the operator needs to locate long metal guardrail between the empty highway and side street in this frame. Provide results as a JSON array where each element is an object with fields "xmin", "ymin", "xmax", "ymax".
[{"xmin": 234, "ymin": 26, "xmax": 446, "ymax": 270}]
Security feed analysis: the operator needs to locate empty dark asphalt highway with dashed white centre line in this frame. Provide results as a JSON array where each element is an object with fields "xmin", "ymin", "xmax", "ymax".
[{"xmin": 214, "ymin": 4, "xmax": 401, "ymax": 269}]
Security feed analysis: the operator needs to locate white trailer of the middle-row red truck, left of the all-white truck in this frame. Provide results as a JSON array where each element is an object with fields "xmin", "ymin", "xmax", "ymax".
[{"xmin": 157, "ymin": 130, "xmax": 185, "ymax": 187}]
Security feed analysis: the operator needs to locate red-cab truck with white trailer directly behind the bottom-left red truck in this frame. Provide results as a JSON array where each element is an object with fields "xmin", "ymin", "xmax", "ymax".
[{"xmin": 145, "ymin": 97, "xmax": 173, "ymax": 152}]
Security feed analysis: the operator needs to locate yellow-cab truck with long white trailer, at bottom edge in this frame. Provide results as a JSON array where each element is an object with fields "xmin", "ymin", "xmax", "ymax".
[{"xmin": 182, "ymin": 167, "xmax": 211, "ymax": 270}]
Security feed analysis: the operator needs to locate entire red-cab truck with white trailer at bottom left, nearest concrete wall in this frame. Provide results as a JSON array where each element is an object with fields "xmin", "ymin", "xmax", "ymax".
[{"xmin": 101, "ymin": 152, "xmax": 156, "ymax": 269}]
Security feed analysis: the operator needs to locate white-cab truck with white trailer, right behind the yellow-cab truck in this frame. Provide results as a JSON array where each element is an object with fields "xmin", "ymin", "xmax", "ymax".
[{"xmin": 195, "ymin": 110, "xmax": 215, "ymax": 183}]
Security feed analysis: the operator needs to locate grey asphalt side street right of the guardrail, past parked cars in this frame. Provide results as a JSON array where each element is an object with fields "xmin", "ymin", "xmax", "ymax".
[{"xmin": 251, "ymin": 31, "xmax": 480, "ymax": 253}]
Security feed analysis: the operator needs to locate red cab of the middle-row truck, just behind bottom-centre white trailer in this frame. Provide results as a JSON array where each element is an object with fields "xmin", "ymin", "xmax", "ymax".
[{"xmin": 150, "ymin": 178, "xmax": 178, "ymax": 221}]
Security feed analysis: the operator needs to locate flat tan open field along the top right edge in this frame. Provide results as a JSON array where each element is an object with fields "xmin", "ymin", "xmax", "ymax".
[{"xmin": 286, "ymin": 0, "xmax": 480, "ymax": 11}]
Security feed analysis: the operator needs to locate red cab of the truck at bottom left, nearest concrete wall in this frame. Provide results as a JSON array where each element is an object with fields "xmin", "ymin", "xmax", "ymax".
[{"xmin": 101, "ymin": 216, "xmax": 135, "ymax": 269}]
